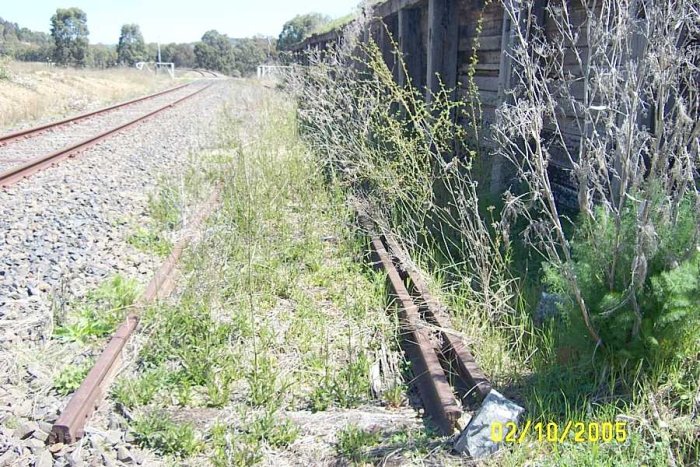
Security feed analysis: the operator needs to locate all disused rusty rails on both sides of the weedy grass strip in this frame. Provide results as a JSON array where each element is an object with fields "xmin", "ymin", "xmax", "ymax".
[{"xmin": 49, "ymin": 210, "xmax": 491, "ymax": 444}]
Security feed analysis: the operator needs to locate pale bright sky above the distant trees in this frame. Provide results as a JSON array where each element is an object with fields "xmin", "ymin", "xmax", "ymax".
[{"xmin": 0, "ymin": 0, "xmax": 359, "ymax": 44}]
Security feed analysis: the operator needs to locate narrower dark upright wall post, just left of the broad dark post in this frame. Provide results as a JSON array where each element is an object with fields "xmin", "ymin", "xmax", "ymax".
[{"xmin": 398, "ymin": 8, "xmax": 425, "ymax": 89}]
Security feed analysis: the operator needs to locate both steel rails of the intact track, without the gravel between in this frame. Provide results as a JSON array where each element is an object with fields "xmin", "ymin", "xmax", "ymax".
[{"xmin": 0, "ymin": 83, "xmax": 212, "ymax": 188}]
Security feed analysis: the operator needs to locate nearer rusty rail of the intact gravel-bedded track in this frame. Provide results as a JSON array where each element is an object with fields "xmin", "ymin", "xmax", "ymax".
[{"xmin": 0, "ymin": 83, "xmax": 213, "ymax": 188}]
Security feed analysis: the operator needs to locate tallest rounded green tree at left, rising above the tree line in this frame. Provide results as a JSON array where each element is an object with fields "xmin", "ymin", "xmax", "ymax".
[{"xmin": 51, "ymin": 8, "xmax": 89, "ymax": 66}]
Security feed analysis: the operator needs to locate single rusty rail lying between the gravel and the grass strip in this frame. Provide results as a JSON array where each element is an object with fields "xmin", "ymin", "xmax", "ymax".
[{"xmin": 48, "ymin": 188, "xmax": 220, "ymax": 444}]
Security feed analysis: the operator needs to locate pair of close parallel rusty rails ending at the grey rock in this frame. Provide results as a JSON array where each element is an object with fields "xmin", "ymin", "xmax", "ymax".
[{"xmin": 360, "ymin": 216, "xmax": 491, "ymax": 435}]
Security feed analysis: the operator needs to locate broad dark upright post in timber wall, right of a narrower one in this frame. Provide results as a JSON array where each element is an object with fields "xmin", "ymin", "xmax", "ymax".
[{"xmin": 426, "ymin": 0, "xmax": 459, "ymax": 102}]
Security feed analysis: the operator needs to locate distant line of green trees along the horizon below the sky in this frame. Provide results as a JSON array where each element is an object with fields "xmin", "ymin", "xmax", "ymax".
[{"xmin": 0, "ymin": 8, "xmax": 340, "ymax": 76}]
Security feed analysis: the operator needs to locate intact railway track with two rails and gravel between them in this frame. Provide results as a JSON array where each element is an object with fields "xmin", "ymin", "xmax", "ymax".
[{"xmin": 0, "ymin": 83, "xmax": 212, "ymax": 188}]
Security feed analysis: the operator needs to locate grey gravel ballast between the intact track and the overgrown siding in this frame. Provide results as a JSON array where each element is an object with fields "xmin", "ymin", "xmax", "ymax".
[{"xmin": 0, "ymin": 81, "xmax": 241, "ymax": 466}]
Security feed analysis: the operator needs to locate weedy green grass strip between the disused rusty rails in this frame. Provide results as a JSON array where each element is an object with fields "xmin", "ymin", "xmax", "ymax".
[{"xmin": 112, "ymin": 89, "xmax": 440, "ymax": 465}]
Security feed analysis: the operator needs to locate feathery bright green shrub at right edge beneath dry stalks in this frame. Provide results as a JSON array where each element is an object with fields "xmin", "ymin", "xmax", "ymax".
[{"xmin": 545, "ymin": 189, "xmax": 700, "ymax": 363}]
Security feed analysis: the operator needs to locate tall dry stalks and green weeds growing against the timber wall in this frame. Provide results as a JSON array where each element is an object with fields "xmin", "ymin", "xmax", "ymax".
[{"xmin": 288, "ymin": 1, "xmax": 700, "ymax": 465}]
